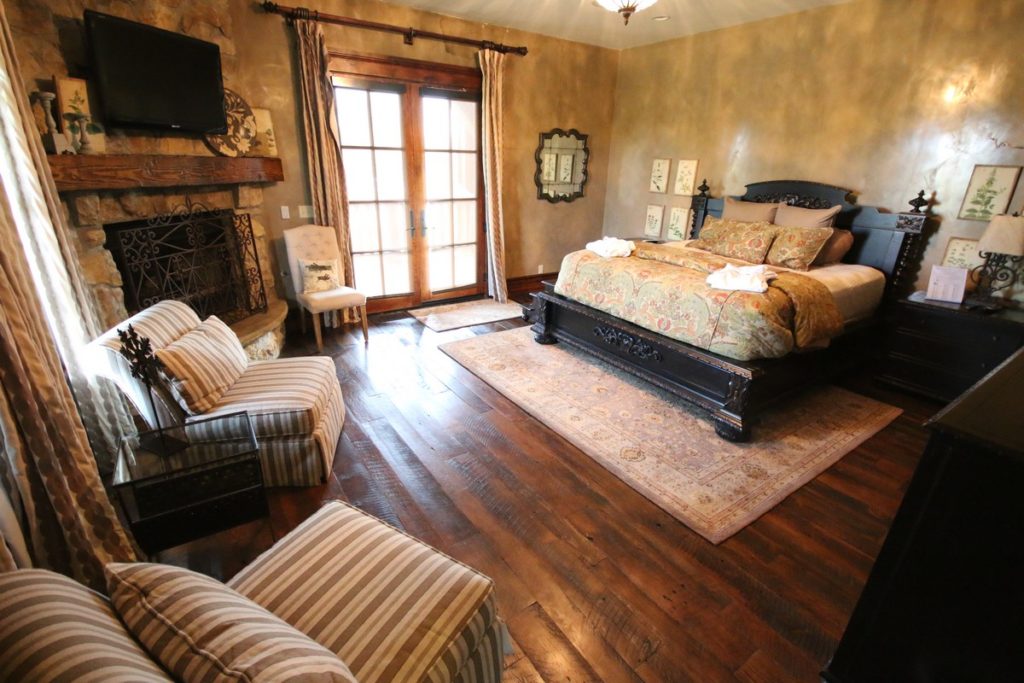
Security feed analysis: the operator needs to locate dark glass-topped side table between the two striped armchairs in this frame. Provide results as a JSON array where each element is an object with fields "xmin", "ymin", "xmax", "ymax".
[{"xmin": 114, "ymin": 413, "xmax": 269, "ymax": 555}]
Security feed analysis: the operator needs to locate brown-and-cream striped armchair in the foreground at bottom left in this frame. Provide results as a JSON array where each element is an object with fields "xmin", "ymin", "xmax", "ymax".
[{"xmin": 0, "ymin": 502, "xmax": 507, "ymax": 683}]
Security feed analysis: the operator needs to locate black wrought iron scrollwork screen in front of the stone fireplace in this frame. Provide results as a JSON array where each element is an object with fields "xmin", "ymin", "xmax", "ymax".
[{"xmin": 104, "ymin": 202, "xmax": 266, "ymax": 324}]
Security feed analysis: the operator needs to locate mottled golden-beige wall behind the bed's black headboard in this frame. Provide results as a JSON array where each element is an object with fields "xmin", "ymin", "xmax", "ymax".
[{"xmin": 604, "ymin": 0, "xmax": 1024, "ymax": 287}]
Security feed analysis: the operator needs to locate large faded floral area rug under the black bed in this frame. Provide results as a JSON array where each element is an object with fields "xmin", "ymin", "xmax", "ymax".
[{"xmin": 439, "ymin": 328, "xmax": 900, "ymax": 544}]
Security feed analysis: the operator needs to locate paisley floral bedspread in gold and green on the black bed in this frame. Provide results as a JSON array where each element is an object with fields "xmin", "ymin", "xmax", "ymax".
[{"xmin": 555, "ymin": 244, "xmax": 843, "ymax": 360}]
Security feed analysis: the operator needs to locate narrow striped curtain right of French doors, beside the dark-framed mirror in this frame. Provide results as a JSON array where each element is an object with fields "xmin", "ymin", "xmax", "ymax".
[{"xmin": 479, "ymin": 50, "xmax": 508, "ymax": 303}]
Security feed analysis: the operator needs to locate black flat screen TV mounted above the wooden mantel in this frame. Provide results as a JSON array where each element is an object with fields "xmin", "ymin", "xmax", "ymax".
[{"xmin": 85, "ymin": 10, "xmax": 227, "ymax": 133}]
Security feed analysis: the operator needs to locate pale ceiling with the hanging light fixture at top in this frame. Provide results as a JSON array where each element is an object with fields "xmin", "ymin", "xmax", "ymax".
[{"xmin": 385, "ymin": 0, "xmax": 850, "ymax": 49}]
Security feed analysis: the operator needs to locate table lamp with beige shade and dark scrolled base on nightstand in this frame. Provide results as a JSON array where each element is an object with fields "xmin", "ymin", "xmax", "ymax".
[{"xmin": 971, "ymin": 213, "xmax": 1024, "ymax": 310}]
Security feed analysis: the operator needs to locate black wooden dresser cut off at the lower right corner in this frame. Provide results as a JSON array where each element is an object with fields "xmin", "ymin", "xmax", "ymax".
[{"xmin": 821, "ymin": 350, "xmax": 1024, "ymax": 683}]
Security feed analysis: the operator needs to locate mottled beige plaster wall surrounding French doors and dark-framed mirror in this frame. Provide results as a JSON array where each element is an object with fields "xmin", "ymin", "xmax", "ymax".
[{"xmin": 231, "ymin": 0, "xmax": 618, "ymax": 278}]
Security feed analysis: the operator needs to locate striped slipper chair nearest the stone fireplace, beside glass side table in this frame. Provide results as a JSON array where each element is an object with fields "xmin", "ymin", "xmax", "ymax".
[{"xmin": 87, "ymin": 300, "xmax": 345, "ymax": 486}]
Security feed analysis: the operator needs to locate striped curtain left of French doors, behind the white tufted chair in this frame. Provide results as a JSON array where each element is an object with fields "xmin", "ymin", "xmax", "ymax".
[{"xmin": 289, "ymin": 18, "xmax": 359, "ymax": 327}]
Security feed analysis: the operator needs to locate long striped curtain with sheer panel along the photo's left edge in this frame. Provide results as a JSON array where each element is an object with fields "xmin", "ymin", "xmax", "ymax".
[{"xmin": 0, "ymin": 0, "xmax": 134, "ymax": 589}]
